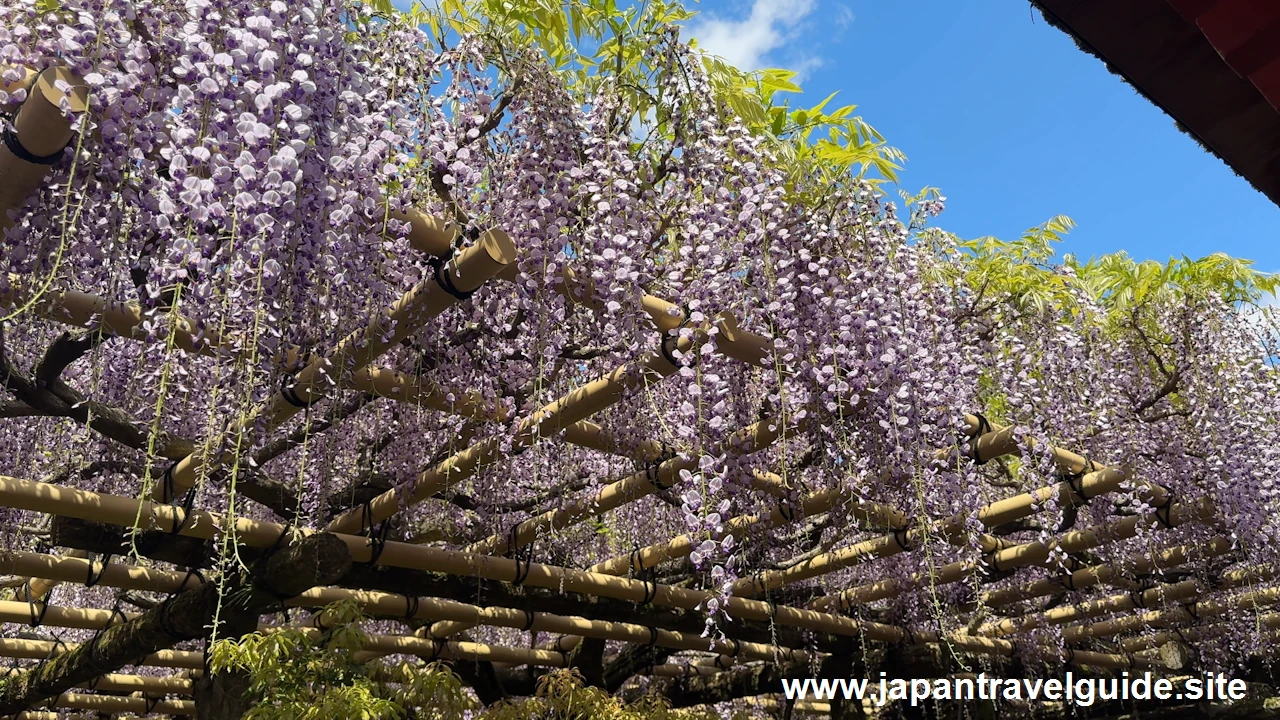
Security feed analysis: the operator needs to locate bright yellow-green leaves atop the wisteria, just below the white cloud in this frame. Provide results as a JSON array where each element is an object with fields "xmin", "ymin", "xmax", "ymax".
[{"xmin": 407, "ymin": 0, "xmax": 905, "ymax": 194}]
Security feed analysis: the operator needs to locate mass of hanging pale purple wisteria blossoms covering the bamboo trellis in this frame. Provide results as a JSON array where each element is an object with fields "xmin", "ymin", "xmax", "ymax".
[{"xmin": 0, "ymin": 0, "xmax": 1280, "ymax": 712}]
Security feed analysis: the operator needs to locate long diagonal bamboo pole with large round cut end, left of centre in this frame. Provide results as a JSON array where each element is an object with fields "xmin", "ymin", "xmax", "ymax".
[{"xmin": 151, "ymin": 229, "xmax": 516, "ymax": 502}]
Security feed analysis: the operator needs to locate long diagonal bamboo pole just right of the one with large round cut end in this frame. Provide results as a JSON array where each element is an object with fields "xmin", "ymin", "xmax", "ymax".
[{"xmin": 328, "ymin": 327, "xmax": 711, "ymax": 533}]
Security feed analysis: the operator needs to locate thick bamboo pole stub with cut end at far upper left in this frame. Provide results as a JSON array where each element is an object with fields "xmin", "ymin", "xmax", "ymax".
[{"xmin": 0, "ymin": 67, "xmax": 88, "ymax": 232}]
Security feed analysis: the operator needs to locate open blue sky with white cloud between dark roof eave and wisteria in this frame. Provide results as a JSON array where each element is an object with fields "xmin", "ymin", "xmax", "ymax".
[{"xmin": 690, "ymin": 0, "xmax": 1280, "ymax": 272}]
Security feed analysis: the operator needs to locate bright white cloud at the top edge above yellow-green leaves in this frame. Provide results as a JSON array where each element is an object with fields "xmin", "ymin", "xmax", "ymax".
[{"xmin": 689, "ymin": 0, "xmax": 817, "ymax": 70}]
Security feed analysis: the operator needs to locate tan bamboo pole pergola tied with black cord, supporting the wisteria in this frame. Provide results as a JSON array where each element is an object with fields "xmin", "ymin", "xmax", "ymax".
[{"xmin": 0, "ymin": 68, "xmax": 1280, "ymax": 717}]
